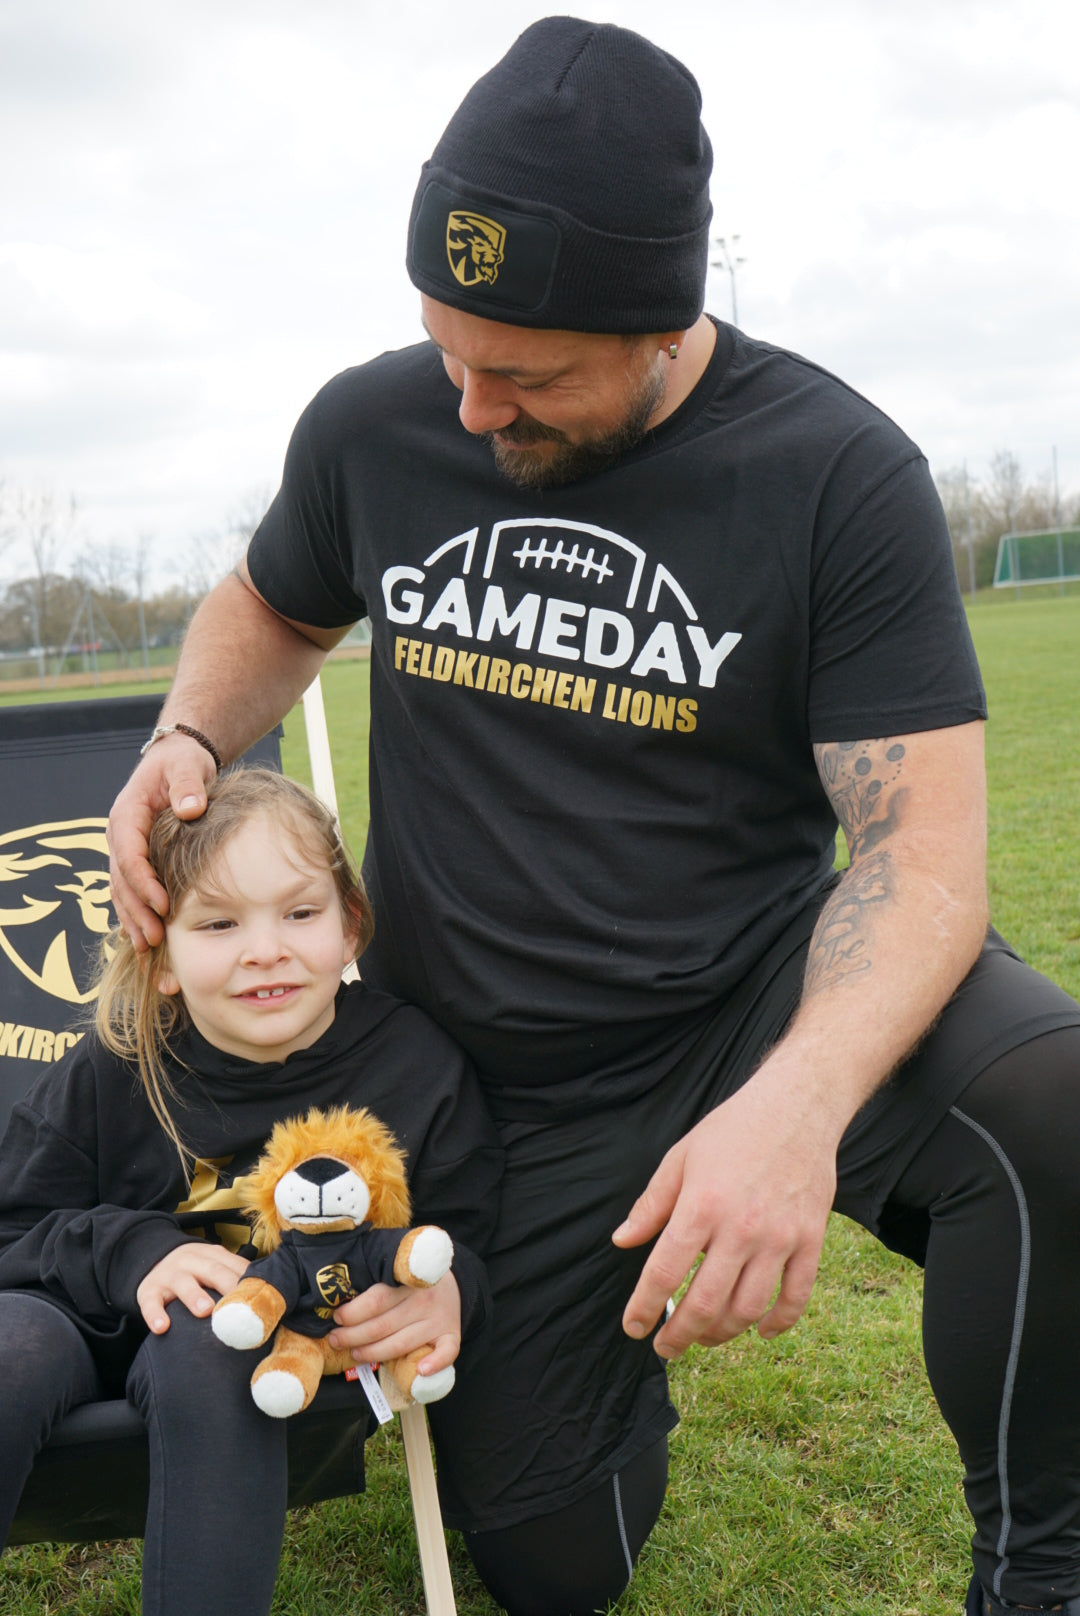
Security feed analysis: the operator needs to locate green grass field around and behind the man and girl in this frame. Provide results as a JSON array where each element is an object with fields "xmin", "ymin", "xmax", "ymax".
[{"xmin": 0, "ymin": 595, "xmax": 1080, "ymax": 1616}]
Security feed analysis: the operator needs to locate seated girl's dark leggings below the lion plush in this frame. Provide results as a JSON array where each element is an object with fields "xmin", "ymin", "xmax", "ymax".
[{"xmin": 0, "ymin": 1291, "xmax": 288, "ymax": 1616}]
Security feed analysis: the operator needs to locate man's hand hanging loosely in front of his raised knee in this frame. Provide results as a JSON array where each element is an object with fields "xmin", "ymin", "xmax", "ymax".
[{"xmin": 613, "ymin": 1052, "xmax": 842, "ymax": 1359}]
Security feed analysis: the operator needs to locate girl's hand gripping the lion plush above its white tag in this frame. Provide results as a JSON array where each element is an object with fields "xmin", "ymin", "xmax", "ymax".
[{"xmin": 330, "ymin": 1273, "xmax": 461, "ymax": 1375}]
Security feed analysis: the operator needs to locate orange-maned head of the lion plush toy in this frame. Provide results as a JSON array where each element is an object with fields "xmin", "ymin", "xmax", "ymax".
[{"xmin": 247, "ymin": 1105, "xmax": 411, "ymax": 1251}]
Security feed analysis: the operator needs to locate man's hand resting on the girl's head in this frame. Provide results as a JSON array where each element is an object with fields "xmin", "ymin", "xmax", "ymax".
[{"xmin": 107, "ymin": 734, "xmax": 215, "ymax": 953}]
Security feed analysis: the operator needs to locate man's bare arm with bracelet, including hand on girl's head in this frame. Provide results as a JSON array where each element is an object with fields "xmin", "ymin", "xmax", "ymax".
[{"xmin": 108, "ymin": 562, "xmax": 349, "ymax": 950}]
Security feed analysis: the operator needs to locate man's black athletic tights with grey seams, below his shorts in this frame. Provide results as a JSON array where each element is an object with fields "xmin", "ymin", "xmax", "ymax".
[{"xmin": 466, "ymin": 1028, "xmax": 1080, "ymax": 1616}]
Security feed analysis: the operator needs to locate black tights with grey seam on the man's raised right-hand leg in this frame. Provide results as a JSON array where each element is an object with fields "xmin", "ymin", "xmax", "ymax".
[{"xmin": 884, "ymin": 1028, "xmax": 1080, "ymax": 1606}]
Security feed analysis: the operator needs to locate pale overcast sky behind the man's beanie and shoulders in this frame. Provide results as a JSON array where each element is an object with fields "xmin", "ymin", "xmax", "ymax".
[{"xmin": 0, "ymin": 0, "xmax": 1080, "ymax": 577}]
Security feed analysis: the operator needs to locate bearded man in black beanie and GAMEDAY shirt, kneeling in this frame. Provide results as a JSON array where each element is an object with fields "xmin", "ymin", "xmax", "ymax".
[{"xmin": 112, "ymin": 18, "xmax": 1080, "ymax": 1616}]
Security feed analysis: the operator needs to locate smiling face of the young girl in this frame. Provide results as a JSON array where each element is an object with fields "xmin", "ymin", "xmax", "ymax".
[{"xmin": 158, "ymin": 814, "xmax": 357, "ymax": 1062}]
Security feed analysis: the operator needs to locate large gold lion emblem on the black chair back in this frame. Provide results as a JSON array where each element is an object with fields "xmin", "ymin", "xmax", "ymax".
[{"xmin": 0, "ymin": 819, "xmax": 110, "ymax": 1005}]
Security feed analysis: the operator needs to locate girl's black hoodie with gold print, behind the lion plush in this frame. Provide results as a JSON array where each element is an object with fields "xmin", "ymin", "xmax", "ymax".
[{"xmin": 0, "ymin": 983, "xmax": 503, "ymax": 1374}]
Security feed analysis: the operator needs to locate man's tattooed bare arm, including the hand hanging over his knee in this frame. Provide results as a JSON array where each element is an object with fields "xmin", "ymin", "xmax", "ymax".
[{"xmin": 614, "ymin": 722, "xmax": 986, "ymax": 1357}]
